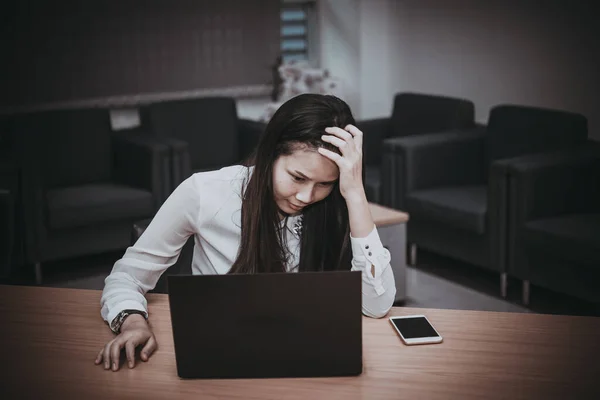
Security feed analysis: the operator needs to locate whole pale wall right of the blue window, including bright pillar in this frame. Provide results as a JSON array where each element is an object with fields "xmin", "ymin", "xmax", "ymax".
[{"xmin": 318, "ymin": 0, "xmax": 600, "ymax": 139}]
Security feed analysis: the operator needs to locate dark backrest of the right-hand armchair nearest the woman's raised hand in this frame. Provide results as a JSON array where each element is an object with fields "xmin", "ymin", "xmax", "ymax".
[{"xmin": 390, "ymin": 93, "xmax": 475, "ymax": 137}]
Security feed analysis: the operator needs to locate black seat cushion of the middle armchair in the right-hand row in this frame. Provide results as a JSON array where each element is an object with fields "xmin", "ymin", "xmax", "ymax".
[{"xmin": 406, "ymin": 185, "xmax": 487, "ymax": 235}]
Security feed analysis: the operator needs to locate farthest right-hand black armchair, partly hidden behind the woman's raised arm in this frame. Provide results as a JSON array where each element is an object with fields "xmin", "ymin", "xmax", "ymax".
[{"xmin": 357, "ymin": 93, "xmax": 475, "ymax": 206}]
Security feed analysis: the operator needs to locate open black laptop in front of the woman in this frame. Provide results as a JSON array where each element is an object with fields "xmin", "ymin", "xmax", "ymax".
[{"xmin": 167, "ymin": 271, "xmax": 362, "ymax": 379}]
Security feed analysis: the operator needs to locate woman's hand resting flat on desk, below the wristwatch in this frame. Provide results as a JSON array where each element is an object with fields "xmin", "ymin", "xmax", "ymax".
[{"xmin": 95, "ymin": 314, "xmax": 158, "ymax": 371}]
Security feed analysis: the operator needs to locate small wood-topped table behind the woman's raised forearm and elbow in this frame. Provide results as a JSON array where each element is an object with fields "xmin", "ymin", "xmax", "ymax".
[{"xmin": 369, "ymin": 203, "xmax": 409, "ymax": 303}]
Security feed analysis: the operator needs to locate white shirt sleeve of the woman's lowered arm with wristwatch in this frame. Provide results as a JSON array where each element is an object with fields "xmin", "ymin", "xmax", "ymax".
[{"xmin": 100, "ymin": 176, "xmax": 200, "ymax": 323}]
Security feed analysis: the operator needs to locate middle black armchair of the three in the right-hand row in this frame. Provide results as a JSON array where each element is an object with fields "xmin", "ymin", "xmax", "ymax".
[{"xmin": 384, "ymin": 105, "xmax": 587, "ymax": 297}]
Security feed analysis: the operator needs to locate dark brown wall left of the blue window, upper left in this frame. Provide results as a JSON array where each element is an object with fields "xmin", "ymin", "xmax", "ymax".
[{"xmin": 0, "ymin": 0, "xmax": 280, "ymax": 114}]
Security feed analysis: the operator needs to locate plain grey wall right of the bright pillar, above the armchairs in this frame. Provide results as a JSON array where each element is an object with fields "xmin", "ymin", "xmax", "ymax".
[{"xmin": 390, "ymin": 0, "xmax": 600, "ymax": 139}]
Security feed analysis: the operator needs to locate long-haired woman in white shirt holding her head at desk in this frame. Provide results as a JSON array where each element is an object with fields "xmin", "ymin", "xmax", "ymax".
[{"xmin": 96, "ymin": 94, "xmax": 396, "ymax": 371}]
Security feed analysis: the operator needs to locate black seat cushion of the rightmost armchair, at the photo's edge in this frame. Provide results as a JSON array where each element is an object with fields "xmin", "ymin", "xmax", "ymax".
[{"xmin": 523, "ymin": 213, "xmax": 600, "ymax": 267}]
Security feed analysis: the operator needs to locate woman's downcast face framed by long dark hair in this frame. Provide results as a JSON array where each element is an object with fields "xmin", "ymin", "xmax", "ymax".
[{"xmin": 273, "ymin": 149, "xmax": 340, "ymax": 214}]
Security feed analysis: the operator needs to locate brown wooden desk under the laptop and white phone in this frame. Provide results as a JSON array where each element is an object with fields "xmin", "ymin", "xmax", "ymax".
[{"xmin": 0, "ymin": 286, "xmax": 600, "ymax": 400}]
